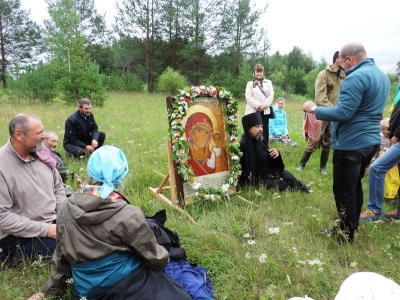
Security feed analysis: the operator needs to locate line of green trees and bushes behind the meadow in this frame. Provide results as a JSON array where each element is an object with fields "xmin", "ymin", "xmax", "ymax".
[{"xmin": 0, "ymin": 0, "xmax": 398, "ymax": 105}]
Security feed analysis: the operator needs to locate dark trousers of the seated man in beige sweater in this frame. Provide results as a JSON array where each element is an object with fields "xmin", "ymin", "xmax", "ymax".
[{"xmin": 0, "ymin": 234, "xmax": 56, "ymax": 267}]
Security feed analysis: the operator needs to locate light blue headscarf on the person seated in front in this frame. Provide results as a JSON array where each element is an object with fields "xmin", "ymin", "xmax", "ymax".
[{"xmin": 87, "ymin": 145, "xmax": 128, "ymax": 199}]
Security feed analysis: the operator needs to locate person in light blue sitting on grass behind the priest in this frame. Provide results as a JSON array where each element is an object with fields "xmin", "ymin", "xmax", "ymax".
[{"xmin": 269, "ymin": 98, "xmax": 298, "ymax": 146}]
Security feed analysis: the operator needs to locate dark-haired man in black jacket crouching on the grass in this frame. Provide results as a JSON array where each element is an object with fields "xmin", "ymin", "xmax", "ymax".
[{"xmin": 64, "ymin": 98, "xmax": 106, "ymax": 158}]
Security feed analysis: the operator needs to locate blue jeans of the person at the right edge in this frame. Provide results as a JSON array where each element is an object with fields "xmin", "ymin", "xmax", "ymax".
[{"xmin": 367, "ymin": 142, "xmax": 400, "ymax": 214}]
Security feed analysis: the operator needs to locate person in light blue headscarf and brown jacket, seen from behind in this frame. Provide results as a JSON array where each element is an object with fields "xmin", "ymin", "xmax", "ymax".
[{"xmin": 31, "ymin": 146, "xmax": 191, "ymax": 300}]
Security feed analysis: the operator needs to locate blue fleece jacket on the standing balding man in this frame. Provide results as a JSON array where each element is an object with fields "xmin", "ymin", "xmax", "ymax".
[{"xmin": 315, "ymin": 58, "xmax": 390, "ymax": 150}]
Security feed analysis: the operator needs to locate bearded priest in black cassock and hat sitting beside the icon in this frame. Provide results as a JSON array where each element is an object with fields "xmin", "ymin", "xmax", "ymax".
[{"xmin": 239, "ymin": 112, "xmax": 311, "ymax": 192}]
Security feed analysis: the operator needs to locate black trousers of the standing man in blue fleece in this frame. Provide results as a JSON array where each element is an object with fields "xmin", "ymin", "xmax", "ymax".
[{"xmin": 333, "ymin": 145, "xmax": 379, "ymax": 241}]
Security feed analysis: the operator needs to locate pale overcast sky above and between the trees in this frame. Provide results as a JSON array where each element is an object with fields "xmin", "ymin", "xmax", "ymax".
[{"xmin": 21, "ymin": 0, "xmax": 400, "ymax": 73}]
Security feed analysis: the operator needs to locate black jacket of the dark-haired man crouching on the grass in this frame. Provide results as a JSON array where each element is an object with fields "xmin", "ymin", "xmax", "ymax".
[{"xmin": 64, "ymin": 110, "xmax": 99, "ymax": 148}]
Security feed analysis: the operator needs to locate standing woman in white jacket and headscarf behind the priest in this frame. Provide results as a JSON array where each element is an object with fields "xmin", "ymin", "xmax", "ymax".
[{"xmin": 244, "ymin": 64, "xmax": 274, "ymax": 145}]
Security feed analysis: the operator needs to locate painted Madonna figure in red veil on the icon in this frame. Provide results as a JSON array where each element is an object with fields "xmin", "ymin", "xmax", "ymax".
[{"xmin": 185, "ymin": 112, "xmax": 215, "ymax": 176}]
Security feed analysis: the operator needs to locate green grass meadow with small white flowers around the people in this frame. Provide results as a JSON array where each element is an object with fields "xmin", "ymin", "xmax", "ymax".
[{"xmin": 0, "ymin": 93, "xmax": 400, "ymax": 300}]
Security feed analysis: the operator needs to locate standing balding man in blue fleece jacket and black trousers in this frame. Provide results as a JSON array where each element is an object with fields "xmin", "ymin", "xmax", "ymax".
[{"xmin": 303, "ymin": 42, "xmax": 390, "ymax": 242}]
